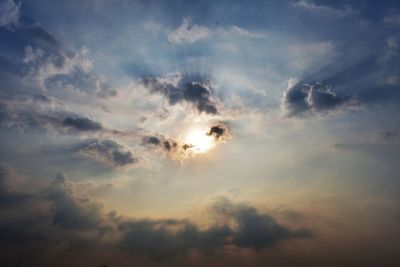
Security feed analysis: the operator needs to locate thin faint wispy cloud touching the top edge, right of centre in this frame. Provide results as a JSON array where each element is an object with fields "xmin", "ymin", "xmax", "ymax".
[{"xmin": 293, "ymin": 0, "xmax": 359, "ymax": 19}]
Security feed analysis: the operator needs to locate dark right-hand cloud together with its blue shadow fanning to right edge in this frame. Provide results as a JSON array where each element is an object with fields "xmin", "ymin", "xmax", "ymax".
[{"xmin": 281, "ymin": 40, "xmax": 400, "ymax": 116}]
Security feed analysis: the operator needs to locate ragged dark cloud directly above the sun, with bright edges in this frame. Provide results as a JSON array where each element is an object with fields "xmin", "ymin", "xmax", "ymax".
[{"xmin": 143, "ymin": 77, "xmax": 218, "ymax": 114}]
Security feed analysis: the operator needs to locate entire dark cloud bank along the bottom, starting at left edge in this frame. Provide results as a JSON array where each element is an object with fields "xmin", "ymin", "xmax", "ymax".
[{"xmin": 0, "ymin": 173, "xmax": 310, "ymax": 260}]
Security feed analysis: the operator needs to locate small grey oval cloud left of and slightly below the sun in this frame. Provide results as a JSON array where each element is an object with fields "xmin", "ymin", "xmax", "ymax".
[{"xmin": 73, "ymin": 139, "xmax": 139, "ymax": 168}]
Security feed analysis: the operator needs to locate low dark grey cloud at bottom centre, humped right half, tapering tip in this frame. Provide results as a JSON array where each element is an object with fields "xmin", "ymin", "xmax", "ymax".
[{"xmin": 118, "ymin": 197, "xmax": 311, "ymax": 258}]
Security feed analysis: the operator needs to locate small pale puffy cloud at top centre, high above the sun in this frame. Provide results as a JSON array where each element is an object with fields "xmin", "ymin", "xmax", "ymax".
[{"xmin": 168, "ymin": 18, "xmax": 210, "ymax": 44}]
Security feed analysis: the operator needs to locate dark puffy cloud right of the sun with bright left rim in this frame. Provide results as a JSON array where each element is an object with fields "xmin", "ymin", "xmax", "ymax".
[{"xmin": 281, "ymin": 83, "xmax": 355, "ymax": 117}]
